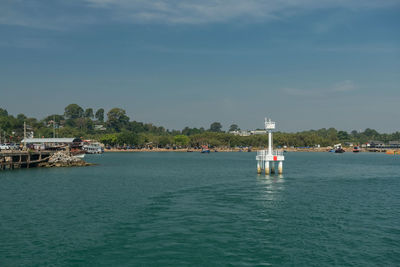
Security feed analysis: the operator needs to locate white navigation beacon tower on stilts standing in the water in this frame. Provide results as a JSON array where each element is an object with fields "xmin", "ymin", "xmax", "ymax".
[{"xmin": 256, "ymin": 118, "xmax": 285, "ymax": 175}]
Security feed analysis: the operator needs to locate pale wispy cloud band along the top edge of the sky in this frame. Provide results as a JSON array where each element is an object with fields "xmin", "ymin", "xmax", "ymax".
[{"xmin": 85, "ymin": 0, "xmax": 399, "ymax": 24}]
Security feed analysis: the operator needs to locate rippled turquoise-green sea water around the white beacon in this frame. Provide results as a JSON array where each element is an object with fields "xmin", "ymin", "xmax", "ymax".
[{"xmin": 0, "ymin": 152, "xmax": 400, "ymax": 266}]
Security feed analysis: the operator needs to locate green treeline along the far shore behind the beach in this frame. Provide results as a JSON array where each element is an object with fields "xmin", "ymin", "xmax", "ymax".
[{"xmin": 0, "ymin": 104, "xmax": 400, "ymax": 147}]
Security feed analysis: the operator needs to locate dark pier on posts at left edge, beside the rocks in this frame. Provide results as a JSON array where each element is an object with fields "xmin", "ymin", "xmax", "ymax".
[{"xmin": 0, "ymin": 150, "xmax": 54, "ymax": 170}]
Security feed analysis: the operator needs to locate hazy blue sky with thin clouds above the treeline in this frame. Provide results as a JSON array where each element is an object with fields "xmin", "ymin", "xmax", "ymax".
[{"xmin": 0, "ymin": 0, "xmax": 400, "ymax": 132}]
